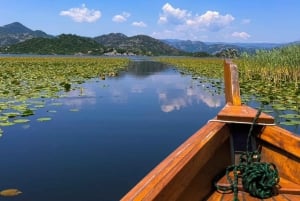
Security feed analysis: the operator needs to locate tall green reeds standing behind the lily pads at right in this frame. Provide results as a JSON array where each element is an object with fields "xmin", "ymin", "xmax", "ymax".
[{"xmin": 237, "ymin": 45, "xmax": 300, "ymax": 88}]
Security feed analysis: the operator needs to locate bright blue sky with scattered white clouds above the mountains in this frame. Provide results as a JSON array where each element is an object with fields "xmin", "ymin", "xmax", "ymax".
[{"xmin": 0, "ymin": 0, "xmax": 300, "ymax": 43}]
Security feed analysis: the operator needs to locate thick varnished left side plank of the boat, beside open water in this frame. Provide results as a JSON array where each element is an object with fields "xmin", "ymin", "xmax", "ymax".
[{"xmin": 121, "ymin": 122, "xmax": 230, "ymax": 201}]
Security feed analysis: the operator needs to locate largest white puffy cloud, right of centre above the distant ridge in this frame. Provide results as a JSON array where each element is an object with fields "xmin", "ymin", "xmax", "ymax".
[{"xmin": 157, "ymin": 3, "xmax": 235, "ymax": 40}]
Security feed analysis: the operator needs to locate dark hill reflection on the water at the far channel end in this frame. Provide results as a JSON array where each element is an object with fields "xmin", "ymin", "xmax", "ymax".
[{"xmin": 121, "ymin": 61, "xmax": 169, "ymax": 77}]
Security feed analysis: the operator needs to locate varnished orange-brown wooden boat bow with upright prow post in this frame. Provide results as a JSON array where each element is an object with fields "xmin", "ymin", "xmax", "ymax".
[{"xmin": 121, "ymin": 60, "xmax": 300, "ymax": 201}]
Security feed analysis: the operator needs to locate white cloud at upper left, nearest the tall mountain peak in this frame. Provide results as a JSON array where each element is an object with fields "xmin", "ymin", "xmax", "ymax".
[{"xmin": 59, "ymin": 4, "xmax": 101, "ymax": 22}]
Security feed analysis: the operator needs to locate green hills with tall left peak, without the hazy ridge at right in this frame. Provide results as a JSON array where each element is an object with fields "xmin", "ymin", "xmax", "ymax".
[{"xmin": 0, "ymin": 22, "xmax": 185, "ymax": 56}]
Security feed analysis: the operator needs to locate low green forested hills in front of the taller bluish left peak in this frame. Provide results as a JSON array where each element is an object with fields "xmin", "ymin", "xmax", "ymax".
[{"xmin": 0, "ymin": 34, "xmax": 185, "ymax": 56}]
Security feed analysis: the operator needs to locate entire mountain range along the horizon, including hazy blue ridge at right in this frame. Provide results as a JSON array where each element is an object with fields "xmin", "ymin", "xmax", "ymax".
[{"xmin": 0, "ymin": 22, "xmax": 299, "ymax": 56}]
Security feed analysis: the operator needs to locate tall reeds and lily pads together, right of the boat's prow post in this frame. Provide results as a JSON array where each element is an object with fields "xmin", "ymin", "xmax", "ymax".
[{"xmin": 236, "ymin": 45, "xmax": 300, "ymax": 128}]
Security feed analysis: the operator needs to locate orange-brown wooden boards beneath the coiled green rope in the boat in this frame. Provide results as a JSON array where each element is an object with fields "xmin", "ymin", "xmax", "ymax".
[{"xmin": 207, "ymin": 175, "xmax": 300, "ymax": 201}]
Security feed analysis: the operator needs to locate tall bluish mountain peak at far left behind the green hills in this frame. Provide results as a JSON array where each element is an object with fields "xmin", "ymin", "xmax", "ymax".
[{"xmin": 0, "ymin": 22, "xmax": 53, "ymax": 47}]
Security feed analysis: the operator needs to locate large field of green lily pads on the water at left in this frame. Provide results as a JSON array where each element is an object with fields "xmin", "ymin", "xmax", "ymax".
[{"xmin": 0, "ymin": 57, "xmax": 130, "ymax": 135}]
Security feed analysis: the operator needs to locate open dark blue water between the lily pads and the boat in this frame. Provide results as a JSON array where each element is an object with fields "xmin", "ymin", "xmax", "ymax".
[{"xmin": 0, "ymin": 61, "xmax": 224, "ymax": 201}]
